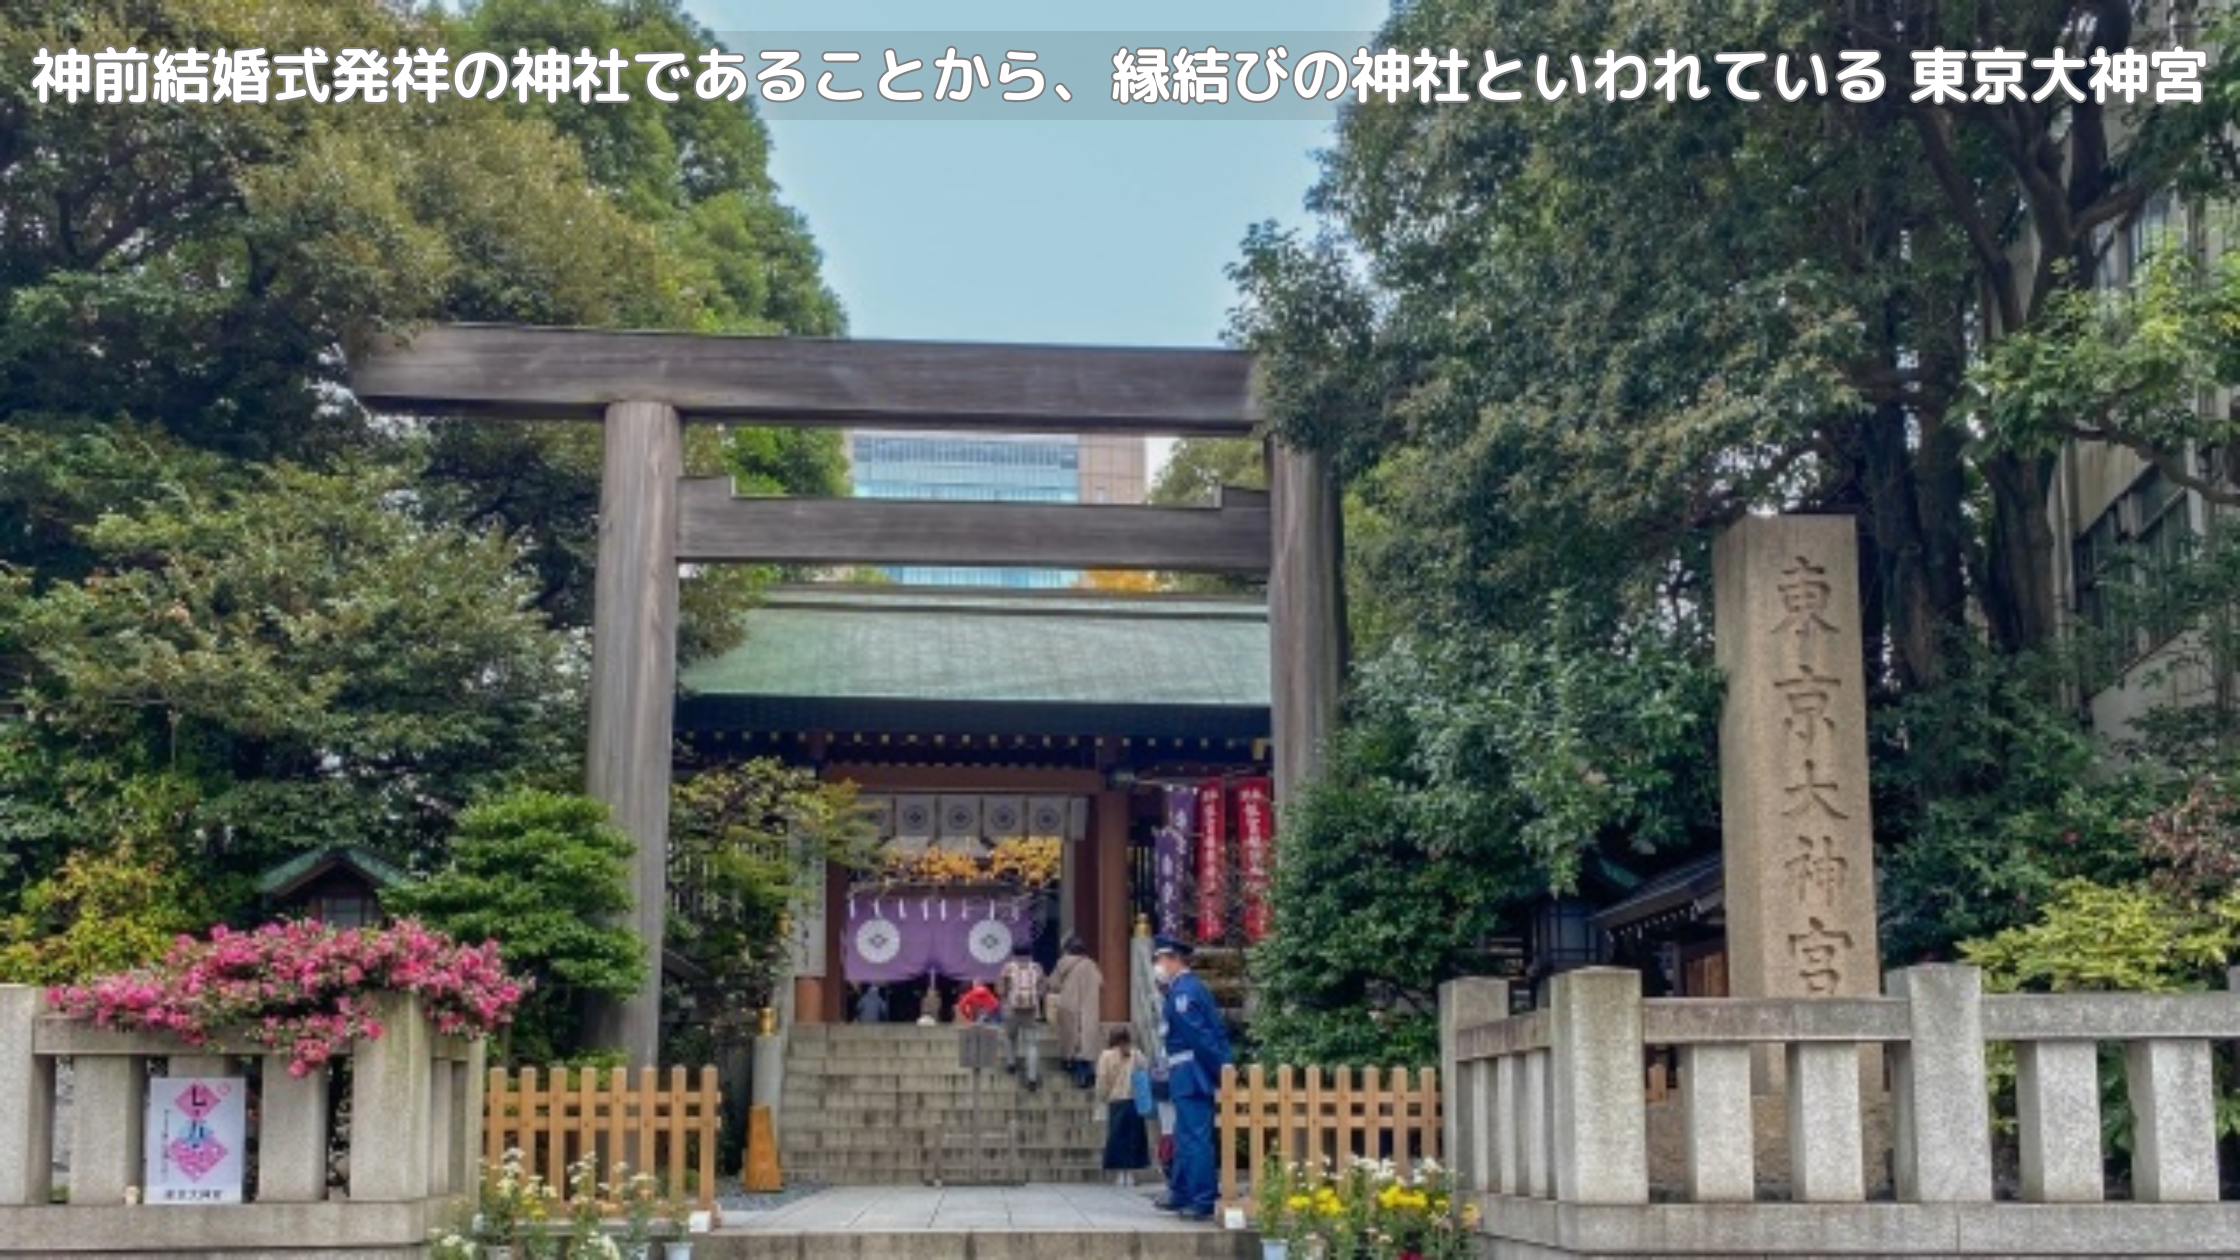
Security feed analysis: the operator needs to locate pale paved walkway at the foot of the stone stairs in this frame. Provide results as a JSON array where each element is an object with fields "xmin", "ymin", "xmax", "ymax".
[{"xmin": 721, "ymin": 1186, "xmax": 1216, "ymax": 1233}]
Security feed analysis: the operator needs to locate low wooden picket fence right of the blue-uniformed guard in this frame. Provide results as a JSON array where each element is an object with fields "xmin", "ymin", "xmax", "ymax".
[{"xmin": 1214, "ymin": 1063, "xmax": 1440, "ymax": 1213}]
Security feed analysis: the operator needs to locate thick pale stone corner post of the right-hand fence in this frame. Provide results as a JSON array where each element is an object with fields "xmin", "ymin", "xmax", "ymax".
[{"xmin": 1548, "ymin": 966, "xmax": 1649, "ymax": 1204}]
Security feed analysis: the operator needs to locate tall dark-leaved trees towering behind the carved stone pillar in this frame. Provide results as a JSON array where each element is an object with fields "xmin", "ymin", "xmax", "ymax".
[{"xmin": 1232, "ymin": 0, "xmax": 2240, "ymax": 995}]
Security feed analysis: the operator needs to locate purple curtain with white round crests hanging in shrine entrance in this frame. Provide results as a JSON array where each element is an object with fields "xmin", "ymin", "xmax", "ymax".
[{"xmin": 840, "ymin": 892, "xmax": 1035, "ymax": 984}]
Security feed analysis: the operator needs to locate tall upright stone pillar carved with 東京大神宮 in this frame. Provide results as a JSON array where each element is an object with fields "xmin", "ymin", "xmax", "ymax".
[{"xmin": 1711, "ymin": 516, "xmax": 1882, "ymax": 1090}]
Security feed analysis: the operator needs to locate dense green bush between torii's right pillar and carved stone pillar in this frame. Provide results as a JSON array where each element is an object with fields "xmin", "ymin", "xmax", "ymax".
[{"xmin": 1252, "ymin": 618, "xmax": 1718, "ymax": 1065}]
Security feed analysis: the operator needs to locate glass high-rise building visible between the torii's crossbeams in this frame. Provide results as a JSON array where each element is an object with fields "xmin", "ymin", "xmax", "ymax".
[{"xmin": 849, "ymin": 428, "xmax": 1145, "ymax": 590}]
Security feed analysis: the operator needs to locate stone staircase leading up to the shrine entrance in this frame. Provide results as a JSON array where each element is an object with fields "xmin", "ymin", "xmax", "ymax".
[{"xmin": 777, "ymin": 1025, "xmax": 1104, "ymax": 1186}]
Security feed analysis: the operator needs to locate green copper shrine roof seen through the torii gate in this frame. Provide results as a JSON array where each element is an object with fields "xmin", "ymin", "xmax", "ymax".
[{"xmin": 679, "ymin": 587, "xmax": 1268, "ymax": 708}]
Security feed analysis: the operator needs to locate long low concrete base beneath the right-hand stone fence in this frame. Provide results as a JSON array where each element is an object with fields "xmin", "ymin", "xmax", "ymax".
[{"xmin": 1478, "ymin": 1195, "xmax": 2240, "ymax": 1260}]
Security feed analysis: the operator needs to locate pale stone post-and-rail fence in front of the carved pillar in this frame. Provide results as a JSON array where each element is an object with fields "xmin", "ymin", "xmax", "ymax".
[{"xmin": 1443, "ymin": 966, "xmax": 2240, "ymax": 1258}]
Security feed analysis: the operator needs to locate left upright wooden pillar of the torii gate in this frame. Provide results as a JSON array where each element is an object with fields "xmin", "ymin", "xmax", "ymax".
[{"xmin": 585, "ymin": 401, "xmax": 685, "ymax": 1063}]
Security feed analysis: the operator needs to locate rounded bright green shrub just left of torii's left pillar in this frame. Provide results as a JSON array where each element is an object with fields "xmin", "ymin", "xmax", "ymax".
[{"xmin": 385, "ymin": 789, "xmax": 645, "ymax": 1060}]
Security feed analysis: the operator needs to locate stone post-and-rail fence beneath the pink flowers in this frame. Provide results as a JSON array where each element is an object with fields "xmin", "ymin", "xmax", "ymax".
[{"xmin": 0, "ymin": 984, "xmax": 484, "ymax": 1260}]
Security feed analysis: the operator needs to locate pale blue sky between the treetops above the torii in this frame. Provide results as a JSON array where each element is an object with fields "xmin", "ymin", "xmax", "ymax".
[{"xmin": 688, "ymin": 0, "xmax": 1389, "ymax": 345}]
